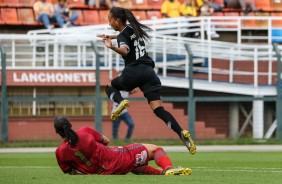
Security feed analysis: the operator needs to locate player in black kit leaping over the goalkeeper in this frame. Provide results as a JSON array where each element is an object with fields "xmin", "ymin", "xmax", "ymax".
[{"xmin": 97, "ymin": 7, "xmax": 196, "ymax": 154}]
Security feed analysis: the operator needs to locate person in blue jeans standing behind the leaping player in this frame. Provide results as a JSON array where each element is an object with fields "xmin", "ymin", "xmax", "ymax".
[{"xmin": 112, "ymin": 91, "xmax": 134, "ymax": 141}]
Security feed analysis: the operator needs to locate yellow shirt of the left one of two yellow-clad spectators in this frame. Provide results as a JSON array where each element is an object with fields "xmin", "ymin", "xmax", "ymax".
[{"xmin": 161, "ymin": 0, "xmax": 181, "ymax": 18}]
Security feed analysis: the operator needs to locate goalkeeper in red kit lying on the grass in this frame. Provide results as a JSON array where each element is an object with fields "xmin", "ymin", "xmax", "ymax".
[{"xmin": 54, "ymin": 116, "xmax": 192, "ymax": 175}]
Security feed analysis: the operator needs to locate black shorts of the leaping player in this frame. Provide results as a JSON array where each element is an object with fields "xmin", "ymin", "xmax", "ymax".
[{"xmin": 111, "ymin": 64, "xmax": 162, "ymax": 102}]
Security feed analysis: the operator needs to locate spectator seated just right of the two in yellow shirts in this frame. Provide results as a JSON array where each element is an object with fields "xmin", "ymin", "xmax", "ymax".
[{"xmin": 200, "ymin": 0, "xmax": 220, "ymax": 38}]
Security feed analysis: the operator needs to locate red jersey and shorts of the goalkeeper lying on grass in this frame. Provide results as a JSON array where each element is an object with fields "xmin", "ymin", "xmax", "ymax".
[{"xmin": 56, "ymin": 127, "xmax": 148, "ymax": 174}]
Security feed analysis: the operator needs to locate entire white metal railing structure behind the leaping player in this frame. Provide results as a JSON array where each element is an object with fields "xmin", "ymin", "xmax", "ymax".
[{"xmin": 0, "ymin": 16, "xmax": 279, "ymax": 87}]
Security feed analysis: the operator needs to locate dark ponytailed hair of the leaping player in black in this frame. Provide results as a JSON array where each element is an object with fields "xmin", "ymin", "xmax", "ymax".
[{"xmin": 110, "ymin": 7, "xmax": 152, "ymax": 40}]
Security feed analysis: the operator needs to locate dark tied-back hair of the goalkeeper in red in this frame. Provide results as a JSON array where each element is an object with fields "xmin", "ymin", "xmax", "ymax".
[{"xmin": 54, "ymin": 116, "xmax": 79, "ymax": 147}]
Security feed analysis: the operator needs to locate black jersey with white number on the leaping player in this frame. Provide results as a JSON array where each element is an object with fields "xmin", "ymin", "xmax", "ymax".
[{"xmin": 117, "ymin": 25, "xmax": 155, "ymax": 67}]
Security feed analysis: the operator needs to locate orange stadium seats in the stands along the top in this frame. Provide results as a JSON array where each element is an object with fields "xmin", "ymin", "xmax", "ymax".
[{"xmin": 0, "ymin": 0, "xmax": 282, "ymax": 29}]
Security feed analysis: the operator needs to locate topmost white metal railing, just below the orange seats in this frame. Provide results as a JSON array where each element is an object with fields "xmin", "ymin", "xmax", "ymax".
[{"xmin": 28, "ymin": 16, "xmax": 282, "ymax": 44}]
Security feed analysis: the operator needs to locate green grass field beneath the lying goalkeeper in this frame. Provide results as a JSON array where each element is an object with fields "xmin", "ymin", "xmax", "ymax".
[{"xmin": 0, "ymin": 152, "xmax": 282, "ymax": 184}]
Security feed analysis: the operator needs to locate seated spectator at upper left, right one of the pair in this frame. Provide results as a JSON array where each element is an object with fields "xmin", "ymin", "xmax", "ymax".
[{"xmin": 54, "ymin": 0, "xmax": 78, "ymax": 26}]
